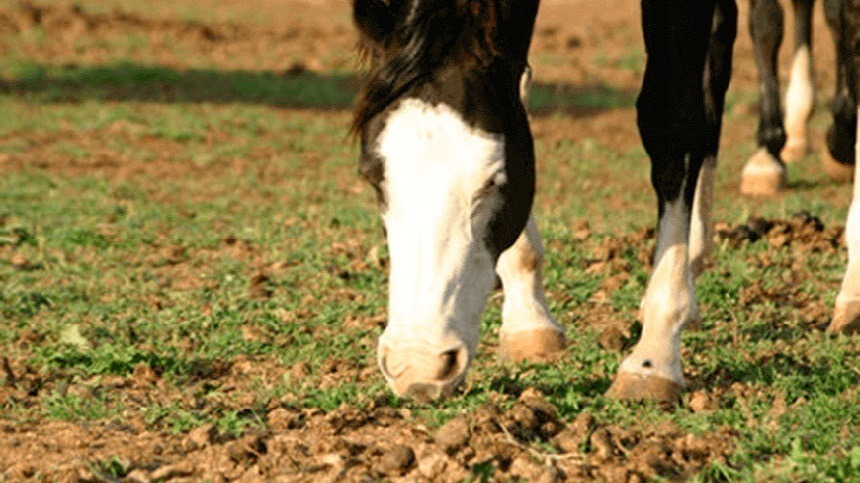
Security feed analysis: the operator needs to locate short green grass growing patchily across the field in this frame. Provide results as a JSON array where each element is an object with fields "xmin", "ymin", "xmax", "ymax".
[{"xmin": 0, "ymin": 33, "xmax": 860, "ymax": 481}]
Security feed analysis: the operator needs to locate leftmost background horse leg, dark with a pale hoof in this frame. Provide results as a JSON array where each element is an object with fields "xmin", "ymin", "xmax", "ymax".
[{"xmin": 740, "ymin": 0, "xmax": 786, "ymax": 196}]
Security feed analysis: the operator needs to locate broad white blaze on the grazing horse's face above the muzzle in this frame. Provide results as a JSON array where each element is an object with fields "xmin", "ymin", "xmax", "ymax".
[{"xmin": 377, "ymin": 99, "xmax": 506, "ymax": 353}]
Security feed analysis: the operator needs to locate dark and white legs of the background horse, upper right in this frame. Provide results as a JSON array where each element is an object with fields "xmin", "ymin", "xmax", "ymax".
[{"xmin": 740, "ymin": 0, "xmax": 857, "ymax": 196}]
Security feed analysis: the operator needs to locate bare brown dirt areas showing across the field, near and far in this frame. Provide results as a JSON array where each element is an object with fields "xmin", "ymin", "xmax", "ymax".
[{"xmin": 0, "ymin": 0, "xmax": 852, "ymax": 482}]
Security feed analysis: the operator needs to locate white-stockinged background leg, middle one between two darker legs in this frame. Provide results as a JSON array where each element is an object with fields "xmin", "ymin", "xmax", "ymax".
[{"xmin": 782, "ymin": 0, "xmax": 815, "ymax": 162}]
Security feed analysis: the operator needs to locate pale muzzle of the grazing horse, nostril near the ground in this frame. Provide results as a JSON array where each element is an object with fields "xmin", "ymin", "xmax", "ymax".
[{"xmin": 378, "ymin": 344, "xmax": 472, "ymax": 401}]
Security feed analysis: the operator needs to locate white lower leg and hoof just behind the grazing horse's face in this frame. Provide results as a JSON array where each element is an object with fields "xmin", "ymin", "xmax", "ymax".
[{"xmin": 496, "ymin": 216, "xmax": 564, "ymax": 361}]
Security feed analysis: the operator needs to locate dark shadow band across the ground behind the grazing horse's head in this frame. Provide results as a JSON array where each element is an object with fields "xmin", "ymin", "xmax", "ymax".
[{"xmin": 0, "ymin": 63, "xmax": 636, "ymax": 116}]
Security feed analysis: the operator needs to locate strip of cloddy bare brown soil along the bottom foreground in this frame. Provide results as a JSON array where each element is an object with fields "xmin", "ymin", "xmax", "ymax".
[{"xmin": 0, "ymin": 378, "xmax": 733, "ymax": 482}]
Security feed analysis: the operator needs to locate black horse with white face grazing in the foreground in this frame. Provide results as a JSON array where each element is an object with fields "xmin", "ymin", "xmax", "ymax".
[{"xmin": 352, "ymin": 0, "xmax": 860, "ymax": 402}]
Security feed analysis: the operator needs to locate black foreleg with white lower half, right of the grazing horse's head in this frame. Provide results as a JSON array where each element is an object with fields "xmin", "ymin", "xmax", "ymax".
[{"xmin": 608, "ymin": 0, "xmax": 737, "ymax": 401}]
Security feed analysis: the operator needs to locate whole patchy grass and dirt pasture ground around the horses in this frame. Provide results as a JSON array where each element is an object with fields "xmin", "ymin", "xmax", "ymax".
[{"xmin": 0, "ymin": 0, "xmax": 860, "ymax": 482}]
